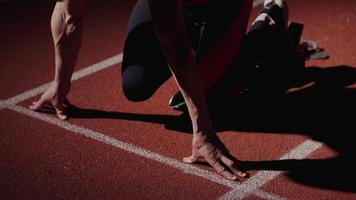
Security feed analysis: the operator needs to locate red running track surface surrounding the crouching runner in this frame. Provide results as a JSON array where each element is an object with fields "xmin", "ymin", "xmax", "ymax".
[{"xmin": 0, "ymin": 0, "xmax": 356, "ymax": 199}]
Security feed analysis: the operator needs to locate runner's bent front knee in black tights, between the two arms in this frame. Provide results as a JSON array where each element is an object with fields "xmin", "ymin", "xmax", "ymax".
[{"xmin": 121, "ymin": 0, "xmax": 172, "ymax": 101}]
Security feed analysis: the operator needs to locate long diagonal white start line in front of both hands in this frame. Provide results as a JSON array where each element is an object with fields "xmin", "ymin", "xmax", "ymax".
[{"xmin": 6, "ymin": 105, "xmax": 283, "ymax": 199}]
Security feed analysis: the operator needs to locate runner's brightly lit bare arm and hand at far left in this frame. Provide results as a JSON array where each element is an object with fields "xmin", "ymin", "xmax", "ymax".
[{"xmin": 29, "ymin": 0, "xmax": 84, "ymax": 120}]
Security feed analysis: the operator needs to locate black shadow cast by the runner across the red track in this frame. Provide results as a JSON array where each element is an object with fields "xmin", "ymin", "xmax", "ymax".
[{"xmin": 64, "ymin": 66, "xmax": 356, "ymax": 192}]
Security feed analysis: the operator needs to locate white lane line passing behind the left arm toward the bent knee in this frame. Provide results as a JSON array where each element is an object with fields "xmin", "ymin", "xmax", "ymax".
[{"xmin": 7, "ymin": 53, "xmax": 122, "ymax": 105}]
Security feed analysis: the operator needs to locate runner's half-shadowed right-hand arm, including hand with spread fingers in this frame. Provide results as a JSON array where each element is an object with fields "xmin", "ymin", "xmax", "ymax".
[{"xmin": 149, "ymin": 0, "xmax": 246, "ymax": 180}]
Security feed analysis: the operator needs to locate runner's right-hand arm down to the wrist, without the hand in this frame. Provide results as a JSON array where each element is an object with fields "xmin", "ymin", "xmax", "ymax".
[{"xmin": 150, "ymin": 0, "xmax": 211, "ymax": 134}]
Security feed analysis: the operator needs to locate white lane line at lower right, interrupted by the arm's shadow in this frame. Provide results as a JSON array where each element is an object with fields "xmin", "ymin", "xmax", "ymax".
[{"xmin": 220, "ymin": 140, "xmax": 322, "ymax": 200}]
